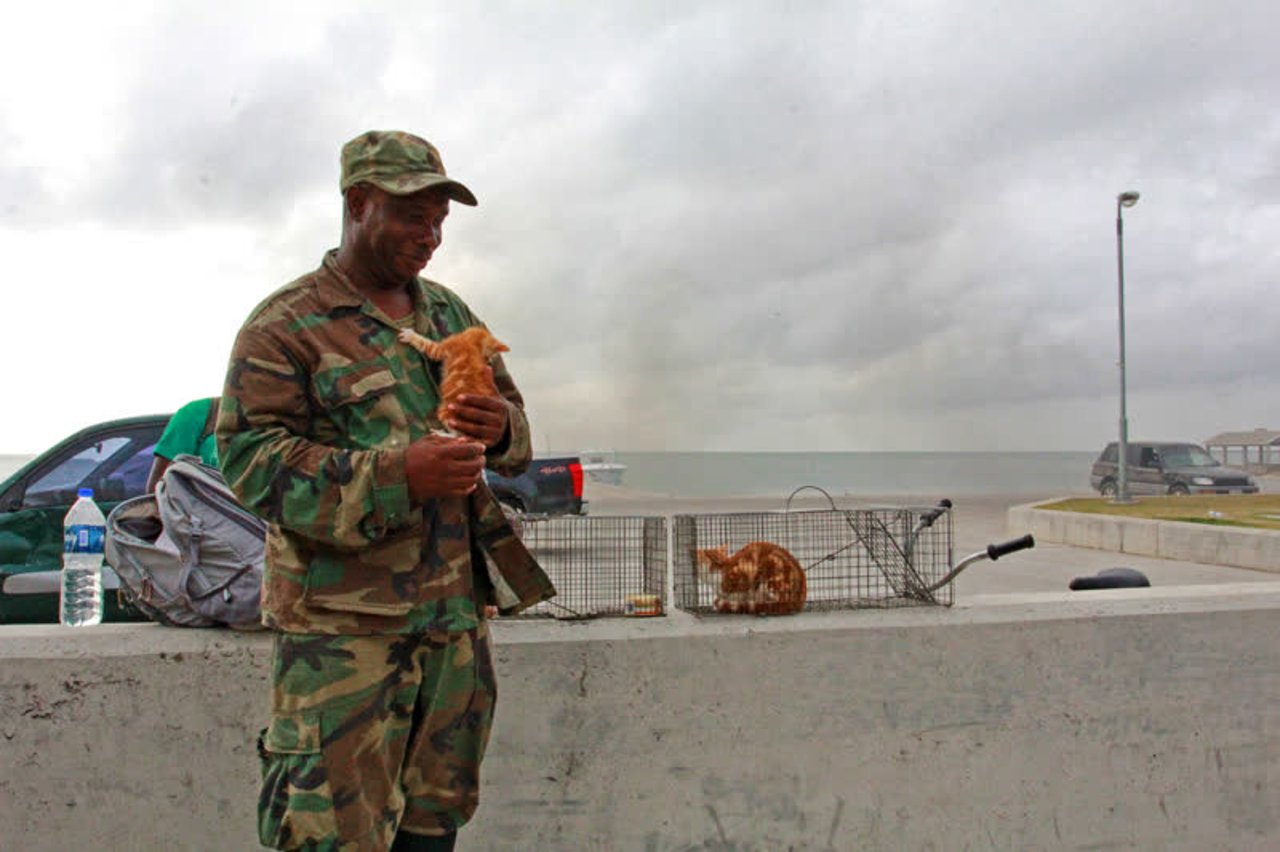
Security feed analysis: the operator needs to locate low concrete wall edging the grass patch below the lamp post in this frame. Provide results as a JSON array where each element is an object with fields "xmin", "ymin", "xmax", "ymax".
[{"xmin": 1007, "ymin": 501, "xmax": 1280, "ymax": 572}]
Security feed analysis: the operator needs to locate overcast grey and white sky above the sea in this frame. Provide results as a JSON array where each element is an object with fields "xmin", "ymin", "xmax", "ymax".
[{"xmin": 0, "ymin": 0, "xmax": 1280, "ymax": 453}]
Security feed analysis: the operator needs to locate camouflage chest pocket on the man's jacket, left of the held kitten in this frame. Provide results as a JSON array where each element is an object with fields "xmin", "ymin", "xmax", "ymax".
[{"xmin": 312, "ymin": 361, "xmax": 408, "ymax": 449}]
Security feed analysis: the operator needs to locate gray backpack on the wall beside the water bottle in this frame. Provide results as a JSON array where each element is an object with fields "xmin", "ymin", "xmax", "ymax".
[{"xmin": 106, "ymin": 455, "xmax": 266, "ymax": 629}]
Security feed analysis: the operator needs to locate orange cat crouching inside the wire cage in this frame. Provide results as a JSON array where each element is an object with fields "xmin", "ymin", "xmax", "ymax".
[{"xmin": 696, "ymin": 541, "xmax": 809, "ymax": 615}]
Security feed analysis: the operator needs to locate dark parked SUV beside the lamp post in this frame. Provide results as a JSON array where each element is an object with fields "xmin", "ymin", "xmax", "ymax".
[{"xmin": 1089, "ymin": 441, "xmax": 1258, "ymax": 496}]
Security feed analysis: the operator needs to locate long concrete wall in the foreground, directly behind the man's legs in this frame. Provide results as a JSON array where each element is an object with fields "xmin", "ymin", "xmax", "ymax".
[{"xmin": 0, "ymin": 583, "xmax": 1280, "ymax": 849}]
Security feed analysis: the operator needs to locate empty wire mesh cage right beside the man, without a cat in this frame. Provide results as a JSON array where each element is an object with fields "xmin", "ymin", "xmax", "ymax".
[{"xmin": 513, "ymin": 516, "xmax": 667, "ymax": 619}]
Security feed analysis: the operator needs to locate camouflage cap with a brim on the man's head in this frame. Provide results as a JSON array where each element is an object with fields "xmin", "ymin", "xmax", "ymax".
[{"xmin": 339, "ymin": 130, "xmax": 476, "ymax": 207}]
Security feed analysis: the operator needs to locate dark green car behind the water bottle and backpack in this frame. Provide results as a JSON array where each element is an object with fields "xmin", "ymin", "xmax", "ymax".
[{"xmin": 0, "ymin": 414, "xmax": 169, "ymax": 624}]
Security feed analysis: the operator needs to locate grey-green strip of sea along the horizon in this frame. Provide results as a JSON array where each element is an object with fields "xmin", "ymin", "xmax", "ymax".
[{"xmin": 0, "ymin": 452, "xmax": 1097, "ymax": 499}]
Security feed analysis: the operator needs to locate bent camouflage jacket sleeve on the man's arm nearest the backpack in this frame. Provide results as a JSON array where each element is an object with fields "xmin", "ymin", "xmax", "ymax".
[{"xmin": 218, "ymin": 320, "xmax": 413, "ymax": 548}]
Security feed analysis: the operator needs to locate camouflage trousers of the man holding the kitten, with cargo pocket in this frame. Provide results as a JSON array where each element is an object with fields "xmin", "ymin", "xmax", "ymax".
[{"xmin": 259, "ymin": 623, "xmax": 497, "ymax": 852}]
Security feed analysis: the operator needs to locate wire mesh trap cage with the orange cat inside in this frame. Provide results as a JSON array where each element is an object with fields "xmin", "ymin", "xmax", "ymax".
[{"xmin": 672, "ymin": 494, "xmax": 954, "ymax": 614}]
